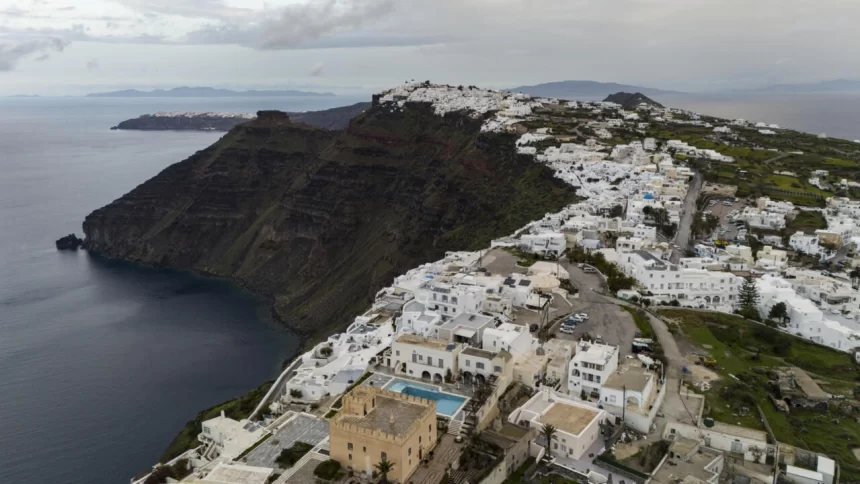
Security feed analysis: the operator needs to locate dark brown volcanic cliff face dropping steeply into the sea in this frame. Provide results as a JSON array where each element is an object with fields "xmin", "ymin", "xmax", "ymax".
[{"xmin": 84, "ymin": 104, "xmax": 575, "ymax": 336}]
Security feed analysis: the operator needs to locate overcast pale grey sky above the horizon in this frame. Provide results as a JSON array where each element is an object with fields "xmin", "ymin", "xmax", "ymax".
[{"xmin": 0, "ymin": 0, "xmax": 860, "ymax": 95}]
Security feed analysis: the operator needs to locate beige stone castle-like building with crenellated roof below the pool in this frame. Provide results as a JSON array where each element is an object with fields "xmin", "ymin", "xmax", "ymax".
[{"xmin": 329, "ymin": 386, "xmax": 437, "ymax": 483}]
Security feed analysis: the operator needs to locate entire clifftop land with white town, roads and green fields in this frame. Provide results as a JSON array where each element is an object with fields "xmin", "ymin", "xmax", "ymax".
[{"xmin": 132, "ymin": 82, "xmax": 860, "ymax": 484}]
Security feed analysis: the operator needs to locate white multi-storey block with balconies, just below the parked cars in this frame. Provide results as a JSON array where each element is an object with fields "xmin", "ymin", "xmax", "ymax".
[{"xmin": 567, "ymin": 341, "xmax": 618, "ymax": 398}]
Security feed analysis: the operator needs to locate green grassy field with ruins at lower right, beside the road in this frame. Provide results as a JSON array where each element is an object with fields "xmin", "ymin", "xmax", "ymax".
[{"xmin": 658, "ymin": 308, "xmax": 860, "ymax": 481}]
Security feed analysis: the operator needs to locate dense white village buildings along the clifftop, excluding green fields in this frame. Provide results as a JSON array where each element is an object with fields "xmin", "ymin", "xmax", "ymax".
[{"xmin": 133, "ymin": 83, "xmax": 860, "ymax": 484}]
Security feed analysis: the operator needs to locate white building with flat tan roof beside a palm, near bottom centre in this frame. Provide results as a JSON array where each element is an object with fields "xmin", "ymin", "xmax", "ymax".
[{"xmin": 508, "ymin": 390, "xmax": 607, "ymax": 460}]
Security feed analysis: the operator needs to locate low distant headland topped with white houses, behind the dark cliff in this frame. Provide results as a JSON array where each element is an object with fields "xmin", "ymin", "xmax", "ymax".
[{"xmin": 111, "ymin": 103, "xmax": 370, "ymax": 131}]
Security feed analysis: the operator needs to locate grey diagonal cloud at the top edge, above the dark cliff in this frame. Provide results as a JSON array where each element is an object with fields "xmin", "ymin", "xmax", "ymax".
[{"xmin": 259, "ymin": 0, "xmax": 394, "ymax": 50}]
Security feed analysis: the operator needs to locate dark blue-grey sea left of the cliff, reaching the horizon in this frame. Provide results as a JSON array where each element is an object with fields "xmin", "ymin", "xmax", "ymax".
[{"xmin": 0, "ymin": 98, "xmax": 358, "ymax": 484}]
